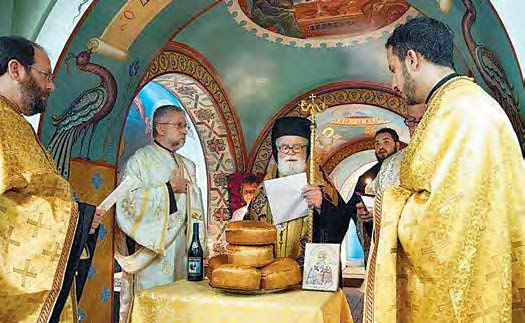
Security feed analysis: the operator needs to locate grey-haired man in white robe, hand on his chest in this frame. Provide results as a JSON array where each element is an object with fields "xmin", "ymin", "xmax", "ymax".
[{"xmin": 115, "ymin": 105, "xmax": 206, "ymax": 322}]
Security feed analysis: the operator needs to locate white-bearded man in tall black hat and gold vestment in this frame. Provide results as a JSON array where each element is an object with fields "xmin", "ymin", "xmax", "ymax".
[{"xmin": 248, "ymin": 117, "xmax": 348, "ymax": 264}]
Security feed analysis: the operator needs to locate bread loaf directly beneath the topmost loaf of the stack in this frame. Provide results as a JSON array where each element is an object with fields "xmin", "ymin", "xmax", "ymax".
[{"xmin": 226, "ymin": 245, "xmax": 274, "ymax": 267}]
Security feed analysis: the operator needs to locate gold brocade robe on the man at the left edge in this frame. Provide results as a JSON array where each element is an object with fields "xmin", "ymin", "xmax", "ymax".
[{"xmin": 0, "ymin": 96, "xmax": 78, "ymax": 322}]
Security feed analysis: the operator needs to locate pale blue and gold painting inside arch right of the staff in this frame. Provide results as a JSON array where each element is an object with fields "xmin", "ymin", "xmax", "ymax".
[{"xmin": 315, "ymin": 104, "xmax": 409, "ymax": 164}]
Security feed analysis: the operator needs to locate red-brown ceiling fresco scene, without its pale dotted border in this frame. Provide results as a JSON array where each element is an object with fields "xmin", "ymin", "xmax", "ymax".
[{"xmin": 238, "ymin": 0, "xmax": 410, "ymax": 39}]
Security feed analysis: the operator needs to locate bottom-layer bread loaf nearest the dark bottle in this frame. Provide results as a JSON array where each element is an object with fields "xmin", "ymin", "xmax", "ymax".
[{"xmin": 210, "ymin": 264, "xmax": 261, "ymax": 290}]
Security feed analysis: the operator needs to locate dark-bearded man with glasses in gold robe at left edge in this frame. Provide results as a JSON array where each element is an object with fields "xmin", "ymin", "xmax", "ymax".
[{"xmin": 0, "ymin": 36, "xmax": 105, "ymax": 322}]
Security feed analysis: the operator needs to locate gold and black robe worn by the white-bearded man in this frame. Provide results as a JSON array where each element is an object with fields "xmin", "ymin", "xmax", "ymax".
[{"xmin": 248, "ymin": 166, "xmax": 346, "ymax": 262}]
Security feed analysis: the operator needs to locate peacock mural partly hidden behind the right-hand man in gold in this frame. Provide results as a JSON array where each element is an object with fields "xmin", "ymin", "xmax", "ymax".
[{"xmin": 462, "ymin": 0, "xmax": 525, "ymax": 155}]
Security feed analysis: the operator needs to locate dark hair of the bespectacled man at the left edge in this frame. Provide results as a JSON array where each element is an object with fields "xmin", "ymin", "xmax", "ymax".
[{"xmin": 0, "ymin": 36, "xmax": 42, "ymax": 76}]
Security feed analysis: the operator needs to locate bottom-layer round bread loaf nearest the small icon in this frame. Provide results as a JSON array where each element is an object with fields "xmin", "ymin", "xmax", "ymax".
[{"xmin": 261, "ymin": 258, "xmax": 302, "ymax": 289}]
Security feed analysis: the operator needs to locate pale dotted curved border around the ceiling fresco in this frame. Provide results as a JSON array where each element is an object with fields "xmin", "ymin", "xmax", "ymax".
[{"xmin": 226, "ymin": 0, "xmax": 420, "ymax": 48}]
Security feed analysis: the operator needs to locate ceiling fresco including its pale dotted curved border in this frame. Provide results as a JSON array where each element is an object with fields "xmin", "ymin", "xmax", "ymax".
[{"xmin": 228, "ymin": 0, "xmax": 418, "ymax": 47}]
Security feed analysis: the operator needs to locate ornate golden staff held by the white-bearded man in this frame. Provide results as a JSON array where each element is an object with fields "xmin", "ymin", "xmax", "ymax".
[{"xmin": 300, "ymin": 94, "xmax": 326, "ymax": 242}]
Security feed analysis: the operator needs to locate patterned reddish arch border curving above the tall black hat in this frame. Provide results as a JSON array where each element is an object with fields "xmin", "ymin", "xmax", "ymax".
[{"xmin": 248, "ymin": 81, "xmax": 406, "ymax": 173}]
